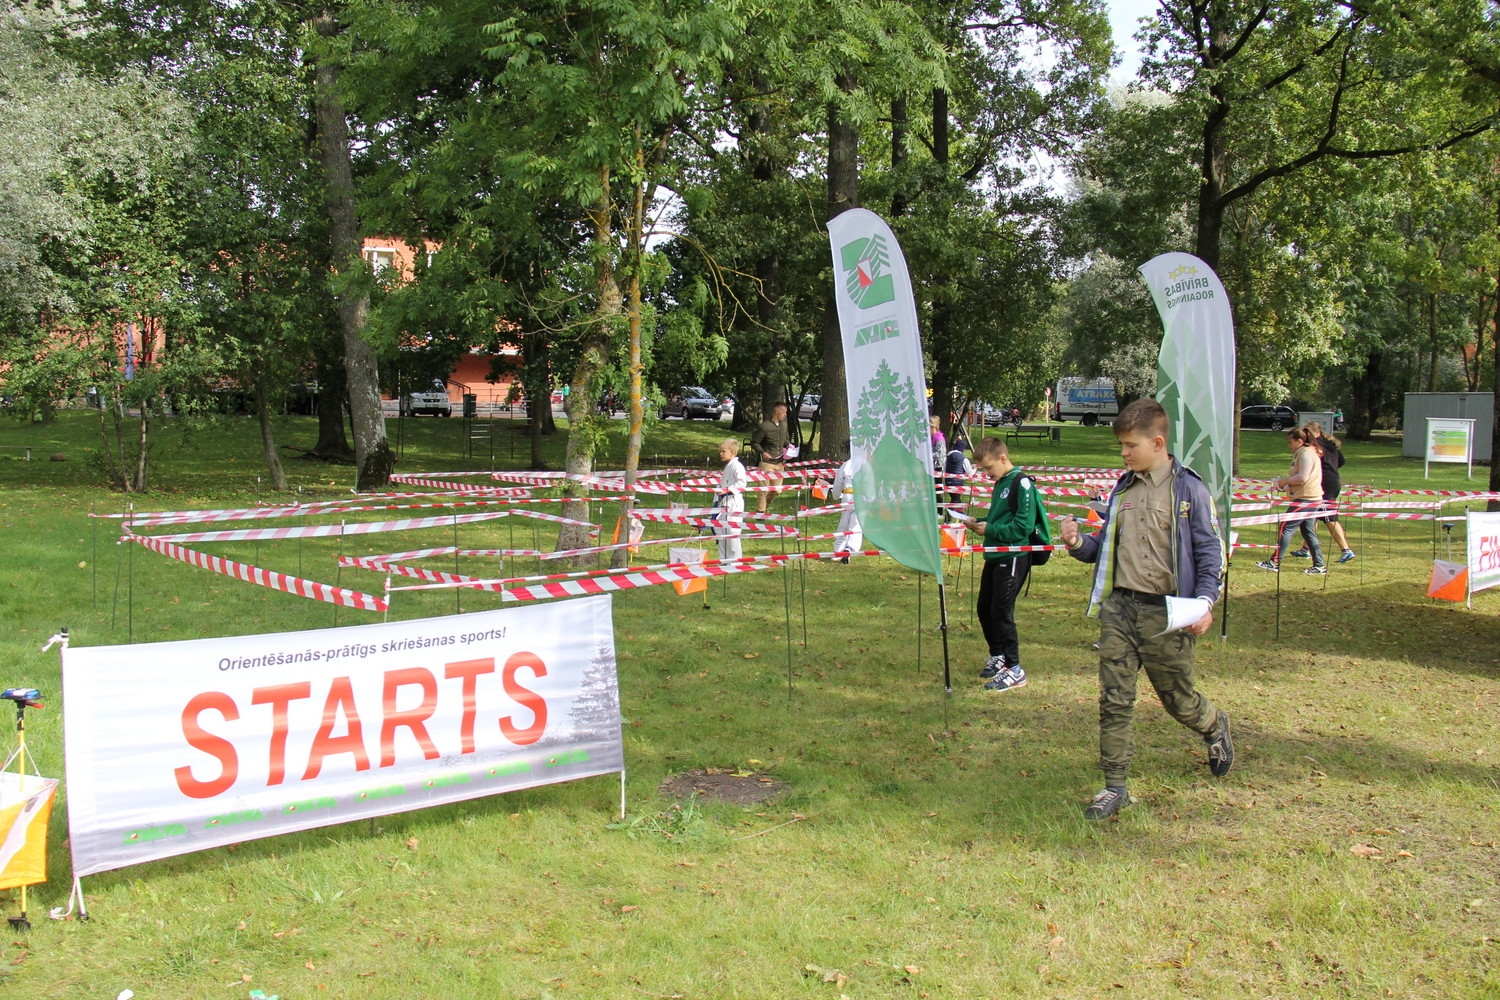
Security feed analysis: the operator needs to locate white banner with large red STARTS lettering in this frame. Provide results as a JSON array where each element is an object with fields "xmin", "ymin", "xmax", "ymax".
[{"xmin": 63, "ymin": 595, "xmax": 624, "ymax": 876}]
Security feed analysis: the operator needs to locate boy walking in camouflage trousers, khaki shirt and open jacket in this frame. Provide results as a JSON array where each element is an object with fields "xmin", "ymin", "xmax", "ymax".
[{"xmin": 1062, "ymin": 399, "xmax": 1235, "ymax": 820}]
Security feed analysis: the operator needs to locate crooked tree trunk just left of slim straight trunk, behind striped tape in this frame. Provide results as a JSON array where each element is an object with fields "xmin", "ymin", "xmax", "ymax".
[{"xmin": 558, "ymin": 166, "xmax": 623, "ymax": 568}]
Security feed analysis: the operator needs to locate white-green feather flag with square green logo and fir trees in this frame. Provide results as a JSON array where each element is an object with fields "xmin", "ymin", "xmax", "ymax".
[{"xmin": 828, "ymin": 208, "xmax": 942, "ymax": 582}]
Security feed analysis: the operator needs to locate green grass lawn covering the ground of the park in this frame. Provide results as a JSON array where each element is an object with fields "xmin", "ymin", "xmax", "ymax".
[{"xmin": 0, "ymin": 414, "xmax": 1500, "ymax": 1000}]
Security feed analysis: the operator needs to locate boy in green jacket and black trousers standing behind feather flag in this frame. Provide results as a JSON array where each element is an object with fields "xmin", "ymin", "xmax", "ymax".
[{"xmin": 968, "ymin": 438, "xmax": 1044, "ymax": 691}]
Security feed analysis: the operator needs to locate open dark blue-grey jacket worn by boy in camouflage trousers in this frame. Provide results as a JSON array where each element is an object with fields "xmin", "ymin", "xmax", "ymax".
[{"xmin": 1068, "ymin": 459, "xmax": 1224, "ymax": 618}]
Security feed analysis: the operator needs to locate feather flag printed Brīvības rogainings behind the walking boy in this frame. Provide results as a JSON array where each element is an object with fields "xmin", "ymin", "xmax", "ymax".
[{"xmin": 1140, "ymin": 253, "xmax": 1235, "ymax": 550}]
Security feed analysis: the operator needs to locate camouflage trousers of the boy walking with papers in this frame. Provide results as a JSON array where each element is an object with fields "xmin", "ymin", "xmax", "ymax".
[{"xmin": 1100, "ymin": 591, "xmax": 1218, "ymax": 786}]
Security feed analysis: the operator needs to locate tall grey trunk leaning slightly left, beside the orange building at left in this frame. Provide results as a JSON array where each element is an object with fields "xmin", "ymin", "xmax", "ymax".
[{"xmin": 314, "ymin": 10, "xmax": 396, "ymax": 490}]
